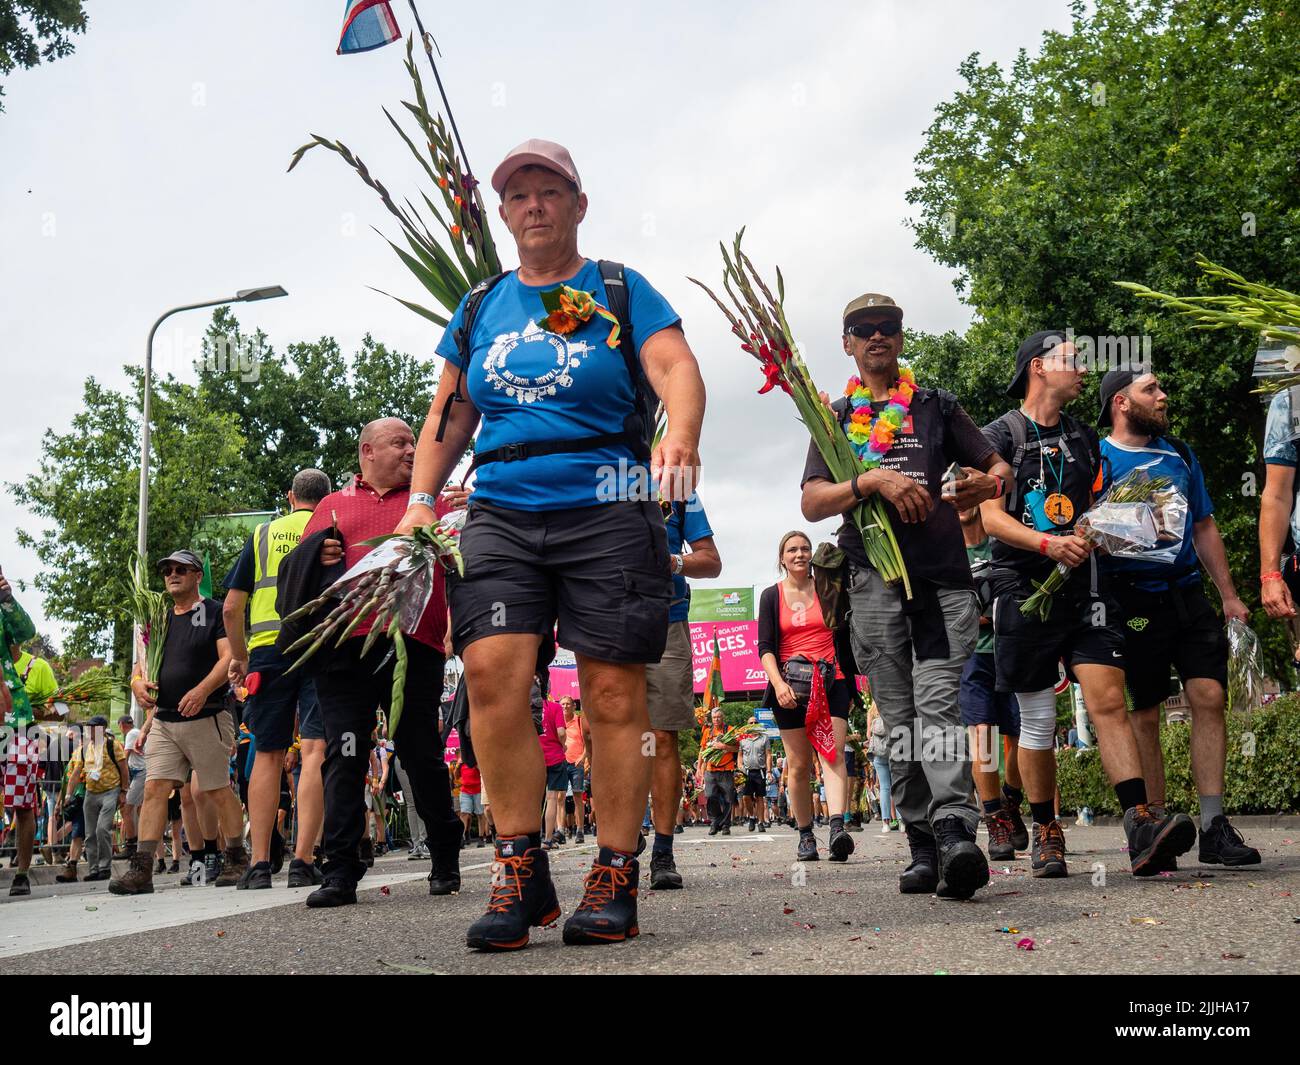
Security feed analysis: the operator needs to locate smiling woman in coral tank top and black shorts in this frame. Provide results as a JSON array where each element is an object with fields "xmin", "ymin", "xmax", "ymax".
[{"xmin": 758, "ymin": 531, "xmax": 853, "ymax": 862}]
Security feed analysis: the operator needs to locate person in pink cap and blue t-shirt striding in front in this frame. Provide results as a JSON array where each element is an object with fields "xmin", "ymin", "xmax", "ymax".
[{"xmin": 397, "ymin": 140, "xmax": 705, "ymax": 951}]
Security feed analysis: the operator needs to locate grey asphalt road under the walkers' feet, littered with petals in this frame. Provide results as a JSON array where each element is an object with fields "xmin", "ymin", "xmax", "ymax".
[{"xmin": 12, "ymin": 822, "xmax": 1300, "ymax": 975}]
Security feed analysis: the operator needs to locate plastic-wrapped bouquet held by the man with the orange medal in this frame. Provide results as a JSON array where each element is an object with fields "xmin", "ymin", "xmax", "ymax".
[{"xmin": 1021, "ymin": 464, "xmax": 1187, "ymax": 620}]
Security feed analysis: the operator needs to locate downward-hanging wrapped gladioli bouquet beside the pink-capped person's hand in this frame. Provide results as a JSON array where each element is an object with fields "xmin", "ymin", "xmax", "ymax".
[{"xmin": 283, "ymin": 523, "xmax": 465, "ymax": 736}]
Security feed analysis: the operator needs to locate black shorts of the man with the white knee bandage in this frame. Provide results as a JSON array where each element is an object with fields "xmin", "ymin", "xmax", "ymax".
[{"xmin": 993, "ymin": 585, "xmax": 1125, "ymax": 692}]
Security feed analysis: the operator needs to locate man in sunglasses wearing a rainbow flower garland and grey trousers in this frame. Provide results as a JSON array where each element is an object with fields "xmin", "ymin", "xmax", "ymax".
[{"xmin": 800, "ymin": 293, "xmax": 1011, "ymax": 899}]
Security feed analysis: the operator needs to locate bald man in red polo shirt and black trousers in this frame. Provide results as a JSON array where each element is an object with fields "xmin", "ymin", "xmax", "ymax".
[{"xmin": 303, "ymin": 417, "xmax": 462, "ymax": 908}]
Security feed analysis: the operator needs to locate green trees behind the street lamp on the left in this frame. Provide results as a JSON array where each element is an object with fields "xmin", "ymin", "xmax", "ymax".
[{"xmin": 8, "ymin": 309, "xmax": 437, "ymax": 662}]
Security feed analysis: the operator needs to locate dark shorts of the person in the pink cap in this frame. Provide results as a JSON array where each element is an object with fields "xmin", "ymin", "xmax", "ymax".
[{"xmin": 447, "ymin": 501, "xmax": 672, "ymax": 666}]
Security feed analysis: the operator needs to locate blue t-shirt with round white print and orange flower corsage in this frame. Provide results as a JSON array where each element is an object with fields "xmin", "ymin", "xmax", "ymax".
[{"xmin": 437, "ymin": 259, "xmax": 681, "ymax": 511}]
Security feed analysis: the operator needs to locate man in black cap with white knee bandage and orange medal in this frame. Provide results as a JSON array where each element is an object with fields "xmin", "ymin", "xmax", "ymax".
[{"xmin": 980, "ymin": 330, "xmax": 1196, "ymax": 876}]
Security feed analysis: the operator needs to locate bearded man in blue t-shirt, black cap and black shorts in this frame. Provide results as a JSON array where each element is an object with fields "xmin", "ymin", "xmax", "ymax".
[{"xmin": 1097, "ymin": 369, "xmax": 1260, "ymax": 866}]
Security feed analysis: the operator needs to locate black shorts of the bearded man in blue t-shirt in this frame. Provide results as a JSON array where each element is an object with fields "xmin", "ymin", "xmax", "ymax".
[{"xmin": 1115, "ymin": 584, "xmax": 1229, "ymax": 710}]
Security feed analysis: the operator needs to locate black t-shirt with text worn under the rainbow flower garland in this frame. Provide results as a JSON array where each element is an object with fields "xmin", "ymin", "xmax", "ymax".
[{"xmin": 800, "ymin": 389, "xmax": 993, "ymax": 588}]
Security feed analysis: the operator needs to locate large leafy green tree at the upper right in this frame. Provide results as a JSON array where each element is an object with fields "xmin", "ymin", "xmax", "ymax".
[{"xmin": 909, "ymin": 0, "xmax": 1300, "ymax": 679}]
